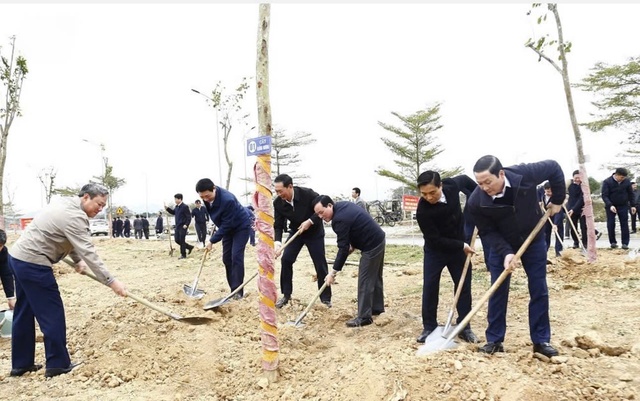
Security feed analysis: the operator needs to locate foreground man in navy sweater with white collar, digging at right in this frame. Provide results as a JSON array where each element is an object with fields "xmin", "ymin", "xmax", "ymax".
[{"xmin": 467, "ymin": 155, "xmax": 566, "ymax": 357}]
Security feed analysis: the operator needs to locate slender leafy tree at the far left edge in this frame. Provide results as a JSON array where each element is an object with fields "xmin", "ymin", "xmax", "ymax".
[{"xmin": 0, "ymin": 36, "xmax": 29, "ymax": 219}]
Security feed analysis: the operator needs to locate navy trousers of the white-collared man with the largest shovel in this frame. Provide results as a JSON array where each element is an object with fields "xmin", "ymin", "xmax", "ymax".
[{"xmin": 485, "ymin": 235, "xmax": 551, "ymax": 344}]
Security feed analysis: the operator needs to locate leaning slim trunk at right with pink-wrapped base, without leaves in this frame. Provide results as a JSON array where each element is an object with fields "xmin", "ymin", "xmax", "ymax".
[{"xmin": 549, "ymin": 4, "xmax": 597, "ymax": 262}]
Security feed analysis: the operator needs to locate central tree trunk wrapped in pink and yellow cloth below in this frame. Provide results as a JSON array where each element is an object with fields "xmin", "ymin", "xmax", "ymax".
[{"xmin": 253, "ymin": 4, "xmax": 280, "ymax": 382}]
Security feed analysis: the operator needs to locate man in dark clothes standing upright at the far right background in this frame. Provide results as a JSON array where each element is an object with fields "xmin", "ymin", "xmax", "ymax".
[{"xmin": 602, "ymin": 167, "xmax": 636, "ymax": 249}]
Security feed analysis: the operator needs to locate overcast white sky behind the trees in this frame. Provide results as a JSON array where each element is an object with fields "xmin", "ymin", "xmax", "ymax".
[{"xmin": 0, "ymin": 3, "xmax": 640, "ymax": 214}]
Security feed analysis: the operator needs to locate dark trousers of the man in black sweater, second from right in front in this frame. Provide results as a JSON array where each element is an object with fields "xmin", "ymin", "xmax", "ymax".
[{"xmin": 422, "ymin": 249, "xmax": 471, "ymax": 330}]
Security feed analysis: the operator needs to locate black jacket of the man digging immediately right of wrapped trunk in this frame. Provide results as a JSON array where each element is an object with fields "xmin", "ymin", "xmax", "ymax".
[{"xmin": 273, "ymin": 186, "xmax": 324, "ymax": 241}]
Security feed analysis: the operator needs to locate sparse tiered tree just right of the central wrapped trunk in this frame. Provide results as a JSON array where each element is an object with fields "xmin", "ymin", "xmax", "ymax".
[{"xmin": 271, "ymin": 129, "xmax": 316, "ymax": 184}]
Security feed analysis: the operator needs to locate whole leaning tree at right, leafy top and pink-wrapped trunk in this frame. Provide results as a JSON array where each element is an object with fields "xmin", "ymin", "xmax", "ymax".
[{"xmin": 525, "ymin": 3, "xmax": 597, "ymax": 262}]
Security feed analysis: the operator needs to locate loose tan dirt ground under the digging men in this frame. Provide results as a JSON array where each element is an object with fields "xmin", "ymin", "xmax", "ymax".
[{"xmin": 0, "ymin": 231, "xmax": 640, "ymax": 401}]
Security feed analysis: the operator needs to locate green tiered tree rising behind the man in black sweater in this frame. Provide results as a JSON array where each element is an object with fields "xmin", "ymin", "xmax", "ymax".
[{"xmin": 376, "ymin": 103, "xmax": 462, "ymax": 190}]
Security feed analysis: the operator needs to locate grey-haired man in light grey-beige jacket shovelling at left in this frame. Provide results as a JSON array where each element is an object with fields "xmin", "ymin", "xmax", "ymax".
[{"xmin": 9, "ymin": 183, "xmax": 127, "ymax": 377}]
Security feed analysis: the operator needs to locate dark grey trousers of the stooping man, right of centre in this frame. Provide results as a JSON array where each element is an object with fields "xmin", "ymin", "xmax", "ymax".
[{"xmin": 358, "ymin": 240, "xmax": 385, "ymax": 319}]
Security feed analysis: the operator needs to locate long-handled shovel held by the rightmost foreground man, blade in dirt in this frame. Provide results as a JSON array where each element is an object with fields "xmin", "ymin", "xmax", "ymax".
[{"xmin": 416, "ymin": 209, "xmax": 551, "ymax": 356}]
